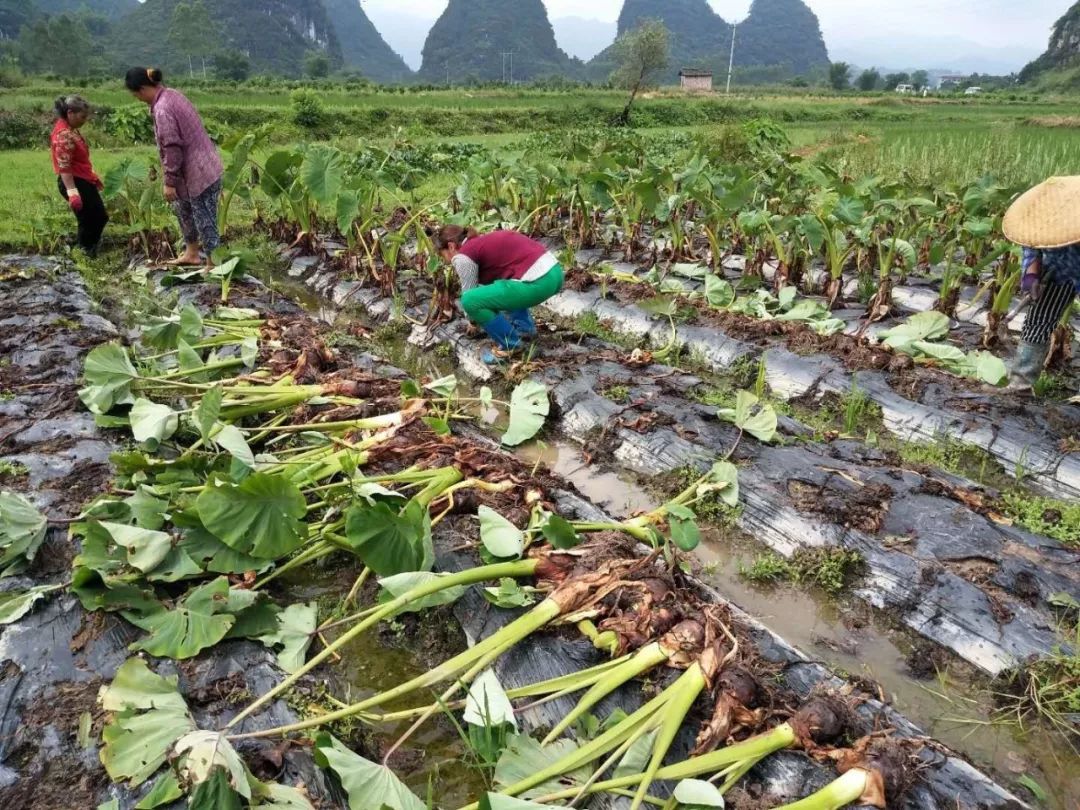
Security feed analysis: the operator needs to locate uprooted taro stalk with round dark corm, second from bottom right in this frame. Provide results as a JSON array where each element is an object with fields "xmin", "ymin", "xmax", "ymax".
[{"xmin": 488, "ymin": 698, "xmax": 851, "ymax": 810}]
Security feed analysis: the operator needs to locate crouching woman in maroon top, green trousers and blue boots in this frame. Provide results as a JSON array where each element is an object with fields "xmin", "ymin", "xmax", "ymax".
[{"xmin": 435, "ymin": 225, "xmax": 563, "ymax": 363}]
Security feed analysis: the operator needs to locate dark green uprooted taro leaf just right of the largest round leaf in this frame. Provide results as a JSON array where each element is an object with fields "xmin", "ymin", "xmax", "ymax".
[{"xmin": 346, "ymin": 501, "xmax": 435, "ymax": 577}]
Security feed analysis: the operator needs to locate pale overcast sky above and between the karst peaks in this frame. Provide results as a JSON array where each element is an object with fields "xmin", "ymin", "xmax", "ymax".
[{"xmin": 362, "ymin": 0, "xmax": 1071, "ymax": 68}]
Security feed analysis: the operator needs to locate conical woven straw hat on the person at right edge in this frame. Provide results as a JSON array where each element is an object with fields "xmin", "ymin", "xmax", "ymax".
[{"xmin": 1002, "ymin": 177, "xmax": 1080, "ymax": 249}]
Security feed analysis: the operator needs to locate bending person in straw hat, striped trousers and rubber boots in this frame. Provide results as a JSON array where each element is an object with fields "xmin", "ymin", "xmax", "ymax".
[{"xmin": 1003, "ymin": 177, "xmax": 1080, "ymax": 388}]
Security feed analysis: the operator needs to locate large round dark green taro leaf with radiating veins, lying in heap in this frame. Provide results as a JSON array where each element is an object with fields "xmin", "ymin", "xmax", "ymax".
[{"xmin": 195, "ymin": 473, "xmax": 308, "ymax": 559}]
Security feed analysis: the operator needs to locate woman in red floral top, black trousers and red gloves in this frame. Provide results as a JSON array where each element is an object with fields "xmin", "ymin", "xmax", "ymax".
[{"xmin": 50, "ymin": 96, "xmax": 109, "ymax": 256}]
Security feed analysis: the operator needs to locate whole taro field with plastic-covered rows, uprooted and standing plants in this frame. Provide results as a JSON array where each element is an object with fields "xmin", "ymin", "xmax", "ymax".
[{"xmin": 0, "ymin": 85, "xmax": 1080, "ymax": 810}]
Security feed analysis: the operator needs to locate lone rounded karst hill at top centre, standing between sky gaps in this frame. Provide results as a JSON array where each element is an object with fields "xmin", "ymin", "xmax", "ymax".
[{"xmin": 419, "ymin": 0, "xmax": 583, "ymax": 83}]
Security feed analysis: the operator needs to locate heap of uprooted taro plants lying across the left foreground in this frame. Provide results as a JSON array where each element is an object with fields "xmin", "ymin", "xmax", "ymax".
[{"xmin": 0, "ymin": 289, "xmax": 903, "ymax": 809}]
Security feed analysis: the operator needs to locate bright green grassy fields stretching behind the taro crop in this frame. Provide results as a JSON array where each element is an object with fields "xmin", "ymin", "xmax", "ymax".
[{"xmin": 6, "ymin": 83, "xmax": 1080, "ymax": 247}]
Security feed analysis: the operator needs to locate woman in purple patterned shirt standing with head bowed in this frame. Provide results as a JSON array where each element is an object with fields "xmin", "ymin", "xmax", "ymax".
[{"xmin": 124, "ymin": 67, "xmax": 222, "ymax": 267}]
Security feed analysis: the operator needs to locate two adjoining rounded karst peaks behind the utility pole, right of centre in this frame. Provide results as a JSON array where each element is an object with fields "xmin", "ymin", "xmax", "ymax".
[{"xmin": 589, "ymin": 0, "xmax": 829, "ymax": 81}]
